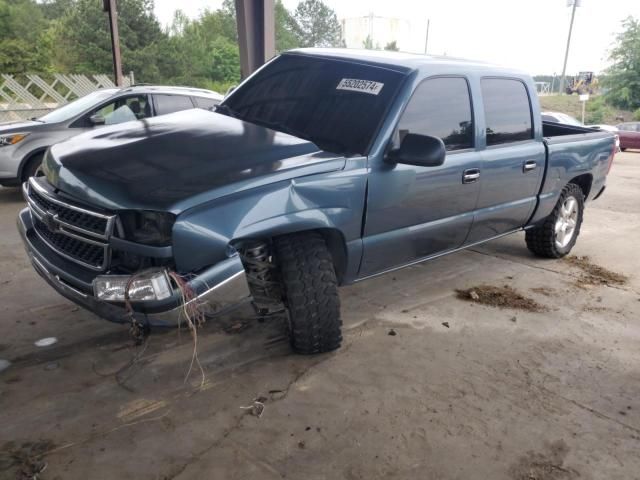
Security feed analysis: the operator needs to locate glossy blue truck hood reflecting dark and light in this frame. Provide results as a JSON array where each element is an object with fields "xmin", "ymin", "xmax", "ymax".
[{"xmin": 44, "ymin": 109, "xmax": 345, "ymax": 214}]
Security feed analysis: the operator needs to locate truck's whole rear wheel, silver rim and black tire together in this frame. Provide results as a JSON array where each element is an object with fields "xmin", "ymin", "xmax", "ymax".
[{"xmin": 525, "ymin": 183, "xmax": 584, "ymax": 258}]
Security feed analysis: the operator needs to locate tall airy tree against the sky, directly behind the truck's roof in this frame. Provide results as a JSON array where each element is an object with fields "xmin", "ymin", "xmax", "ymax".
[{"xmin": 293, "ymin": 0, "xmax": 344, "ymax": 47}]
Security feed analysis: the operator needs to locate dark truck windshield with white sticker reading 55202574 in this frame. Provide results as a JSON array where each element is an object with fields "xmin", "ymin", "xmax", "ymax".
[{"xmin": 216, "ymin": 55, "xmax": 404, "ymax": 155}]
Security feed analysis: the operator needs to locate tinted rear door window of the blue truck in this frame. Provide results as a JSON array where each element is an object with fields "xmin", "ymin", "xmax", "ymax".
[{"xmin": 481, "ymin": 78, "xmax": 533, "ymax": 146}]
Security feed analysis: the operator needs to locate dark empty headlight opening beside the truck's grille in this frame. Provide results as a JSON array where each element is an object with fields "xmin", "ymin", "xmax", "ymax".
[{"xmin": 120, "ymin": 210, "xmax": 176, "ymax": 247}]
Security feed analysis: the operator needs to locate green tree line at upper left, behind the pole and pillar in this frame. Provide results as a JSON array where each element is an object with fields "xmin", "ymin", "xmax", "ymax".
[{"xmin": 0, "ymin": 0, "xmax": 343, "ymax": 88}]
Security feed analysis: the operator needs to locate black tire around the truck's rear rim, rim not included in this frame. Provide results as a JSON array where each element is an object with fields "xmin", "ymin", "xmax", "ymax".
[{"xmin": 524, "ymin": 183, "xmax": 584, "ymax": 258}]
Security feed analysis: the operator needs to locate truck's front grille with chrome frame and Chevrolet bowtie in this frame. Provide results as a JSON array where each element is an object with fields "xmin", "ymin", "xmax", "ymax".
[{"xmin": 24, "ymin": 178, "xmax": 115, "ymax": 271}]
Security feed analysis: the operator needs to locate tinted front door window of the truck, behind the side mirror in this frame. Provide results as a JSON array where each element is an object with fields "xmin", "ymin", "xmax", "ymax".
[{"xmin": 394, "ymin": 77, "xmax": 474, "ymax": 151}]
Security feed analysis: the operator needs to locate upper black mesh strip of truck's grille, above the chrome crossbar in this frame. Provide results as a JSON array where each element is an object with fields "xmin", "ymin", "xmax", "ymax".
[{"xmin": 28, "ymin": 180, "xmax": 110, "ymax": 238}]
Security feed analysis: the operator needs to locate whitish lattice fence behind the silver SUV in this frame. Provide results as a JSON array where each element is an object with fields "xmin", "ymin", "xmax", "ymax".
[{"xmin": 0, "ymin": 74, "xmax": 133, "ymax": 122}]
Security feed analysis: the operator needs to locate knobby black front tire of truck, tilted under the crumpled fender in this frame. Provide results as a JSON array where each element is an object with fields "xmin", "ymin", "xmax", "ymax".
[{"xmin": 274, "ymin": 232, "xmax": 342, "ymax": 355}]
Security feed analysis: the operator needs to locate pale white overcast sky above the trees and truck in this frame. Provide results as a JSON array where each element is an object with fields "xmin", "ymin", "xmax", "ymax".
[{"xmin": 155, "ymin": 0, "xmax": 640, "ymax": 75}]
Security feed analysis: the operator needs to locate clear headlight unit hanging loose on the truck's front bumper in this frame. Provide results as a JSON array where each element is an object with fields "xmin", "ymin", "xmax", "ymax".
[{"xmin": 93, "ymin": 271, "xmax": 173, "ymax": 302}]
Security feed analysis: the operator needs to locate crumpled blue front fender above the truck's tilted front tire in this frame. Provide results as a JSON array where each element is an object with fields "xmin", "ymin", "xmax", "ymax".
[{"xmin": 173, "ymin": 157, "xmax": 367, "ymax": 278}]
